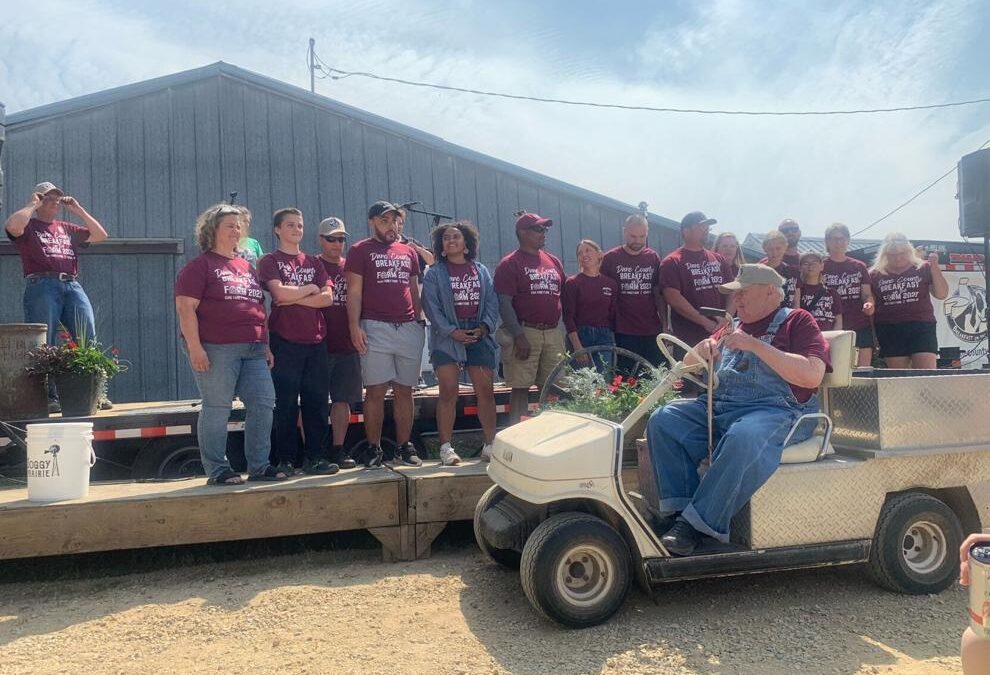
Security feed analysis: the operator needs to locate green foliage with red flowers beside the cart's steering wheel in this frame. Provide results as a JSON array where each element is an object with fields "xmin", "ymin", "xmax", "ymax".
[{"xmin": 547, "ymin": 367, "xmax": 677, "ymax": 422}]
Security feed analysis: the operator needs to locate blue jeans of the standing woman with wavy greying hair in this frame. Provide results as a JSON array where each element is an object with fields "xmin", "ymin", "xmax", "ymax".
[{"xmin": 193, "ymin": 342, "xmax": 275, "ymax": 478}]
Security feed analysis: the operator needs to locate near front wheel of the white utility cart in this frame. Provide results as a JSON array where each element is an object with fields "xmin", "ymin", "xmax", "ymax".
[{"xmin": 519, "ymin": 512, "xmax": 632, "ymax": 628}]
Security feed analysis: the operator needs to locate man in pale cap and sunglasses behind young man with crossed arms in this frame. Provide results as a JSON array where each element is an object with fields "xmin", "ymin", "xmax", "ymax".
[{"xmin": 320, "ymin": 217, "xmax": 362, "ymax": 469}]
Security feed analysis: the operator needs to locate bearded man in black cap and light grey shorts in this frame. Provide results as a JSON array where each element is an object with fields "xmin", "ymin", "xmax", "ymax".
[{"xmin": 344, "ymin": 201, "xmax": 426, "ymax": 469}]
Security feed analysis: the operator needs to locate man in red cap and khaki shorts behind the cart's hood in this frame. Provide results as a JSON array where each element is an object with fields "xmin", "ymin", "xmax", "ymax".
[{"xmin": 495, "ymin": 212, "xmax": 566, "ymax": 423}]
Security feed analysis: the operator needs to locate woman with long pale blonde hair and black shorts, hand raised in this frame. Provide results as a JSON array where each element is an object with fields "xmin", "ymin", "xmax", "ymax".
[{"xmin": 870, "ymin": 232, "xmax": 949, "ymax": 369}]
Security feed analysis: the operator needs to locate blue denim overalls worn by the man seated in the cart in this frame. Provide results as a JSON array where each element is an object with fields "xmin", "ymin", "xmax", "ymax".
[{"xmin": 647, "ymin": 308, "xmax": 818, "ymax": 542}]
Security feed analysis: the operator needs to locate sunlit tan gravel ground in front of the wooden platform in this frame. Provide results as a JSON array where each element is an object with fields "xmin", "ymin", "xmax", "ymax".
[{"xmin": 0, "ymin": 531, "xmax": 966, "ymax": 675}]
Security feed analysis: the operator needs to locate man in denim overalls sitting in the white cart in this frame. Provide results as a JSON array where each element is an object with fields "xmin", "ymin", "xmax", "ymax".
[{"xmin": 647, "ymin": 265, "xmax": 830, "ymax": 555}]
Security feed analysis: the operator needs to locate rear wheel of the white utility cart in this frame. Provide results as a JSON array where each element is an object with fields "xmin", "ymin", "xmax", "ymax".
[{"xmin": 869, "ymin": 492, "xmax": 963, "ymax": 595}]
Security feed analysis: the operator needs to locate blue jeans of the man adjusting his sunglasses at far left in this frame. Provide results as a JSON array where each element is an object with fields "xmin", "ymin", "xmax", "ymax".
[{"xmin": 24, "ymin": 277, "xmax": 96, "ymax": 345}]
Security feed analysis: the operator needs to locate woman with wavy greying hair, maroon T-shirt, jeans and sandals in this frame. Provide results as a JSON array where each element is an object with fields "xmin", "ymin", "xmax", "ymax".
[{"xmin": 175, "ymin": 204, "xmax": 287, "ymax": 485}]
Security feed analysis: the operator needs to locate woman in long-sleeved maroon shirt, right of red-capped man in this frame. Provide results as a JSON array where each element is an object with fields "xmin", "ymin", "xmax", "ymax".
[{"xmin": 560, "ymin": 239, "xmax": 619, "ymax": 371}]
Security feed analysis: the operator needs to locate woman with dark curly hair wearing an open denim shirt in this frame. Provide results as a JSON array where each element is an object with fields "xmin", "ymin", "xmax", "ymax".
[{"xmin": 423, "ymin": 221, "xmax": 499, "ymax": 466}]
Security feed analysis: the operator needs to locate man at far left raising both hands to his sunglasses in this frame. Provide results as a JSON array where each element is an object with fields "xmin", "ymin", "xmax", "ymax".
[{"xmin": 5, "ymin": 181, "xmax": 109, "ymax": 412}]
